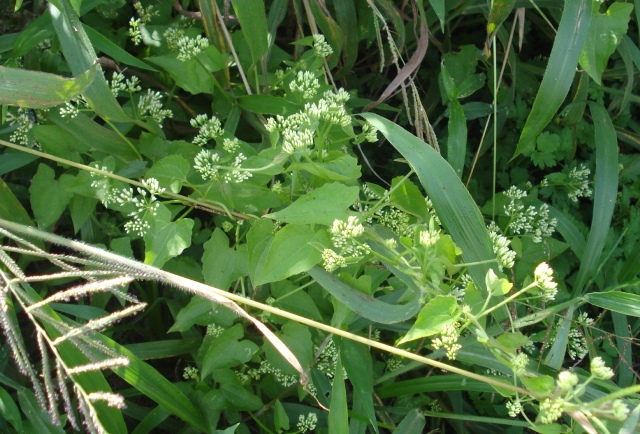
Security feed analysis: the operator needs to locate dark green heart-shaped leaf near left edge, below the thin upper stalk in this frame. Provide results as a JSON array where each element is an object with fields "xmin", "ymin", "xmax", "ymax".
[{"xmin": 29, "ymin": 164, "xmax": 73, "ymax": 228}]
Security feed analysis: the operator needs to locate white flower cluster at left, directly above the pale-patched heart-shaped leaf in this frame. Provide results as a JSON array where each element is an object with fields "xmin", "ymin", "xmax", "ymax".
[{"xmin": 115, "ymin": 178, "xmax": 165, "ymax": 237}]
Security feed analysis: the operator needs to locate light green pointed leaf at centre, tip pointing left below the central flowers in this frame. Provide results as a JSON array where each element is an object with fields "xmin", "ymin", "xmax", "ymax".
[{"xmin": 264, "ymin": 182, "xmax": 360, "ymax": 226}]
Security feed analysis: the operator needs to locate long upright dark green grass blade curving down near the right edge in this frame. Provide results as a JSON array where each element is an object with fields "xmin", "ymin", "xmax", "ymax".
[{"xmin": 574, "ymin": 102, "xmax": 618, "ymax": 294}]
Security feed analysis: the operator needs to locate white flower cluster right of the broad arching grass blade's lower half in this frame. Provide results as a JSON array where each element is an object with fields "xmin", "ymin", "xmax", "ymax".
[{"xmin": 504, "ymin": 185, "xmax": 558, "ymax": 243}]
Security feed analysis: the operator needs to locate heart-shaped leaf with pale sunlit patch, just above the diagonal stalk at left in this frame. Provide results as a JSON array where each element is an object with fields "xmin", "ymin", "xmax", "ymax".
[{"xmin": 144, "ymin": 205, "xmax": 193, "ymax": 268}]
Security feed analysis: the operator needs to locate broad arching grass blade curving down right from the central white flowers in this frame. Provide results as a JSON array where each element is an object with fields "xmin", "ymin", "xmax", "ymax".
[{"xmin": 362, "ymin": 113, "xmax": 497, "ymax": 294}]
